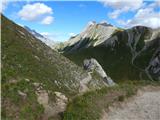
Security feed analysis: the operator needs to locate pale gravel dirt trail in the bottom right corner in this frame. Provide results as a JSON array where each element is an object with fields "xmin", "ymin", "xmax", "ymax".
[{"xmin": 101, "ymin": 86, "xmax": 160, "ymax": 120}]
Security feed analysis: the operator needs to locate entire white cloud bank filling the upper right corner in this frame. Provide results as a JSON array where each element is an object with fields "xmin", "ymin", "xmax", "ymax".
[{"xmin": 100, "ymin": 0, "xmax": 160, "ymax": 28}]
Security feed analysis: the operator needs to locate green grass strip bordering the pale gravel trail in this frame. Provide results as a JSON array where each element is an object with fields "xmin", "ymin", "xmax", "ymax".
[{"xmin": 63, "ymin": 81, "xmax": 160, "ymax": 120}]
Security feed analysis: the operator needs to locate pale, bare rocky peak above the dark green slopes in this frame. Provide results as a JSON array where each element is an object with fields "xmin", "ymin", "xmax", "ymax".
[{"xmin": 57, "ymin": 21, "xmax": 121, "ymax": 52}]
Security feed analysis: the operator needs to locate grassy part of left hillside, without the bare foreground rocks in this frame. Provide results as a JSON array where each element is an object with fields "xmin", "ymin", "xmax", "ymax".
[{"xmin": 1, "ymin": 16, "xmax": 86, "ymax": 120}]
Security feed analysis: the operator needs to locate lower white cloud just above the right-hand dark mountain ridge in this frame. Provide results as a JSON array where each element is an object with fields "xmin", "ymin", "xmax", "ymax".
[{"xmin": 126, "ymin": 8, "xmax": 160, "ymax": 28}]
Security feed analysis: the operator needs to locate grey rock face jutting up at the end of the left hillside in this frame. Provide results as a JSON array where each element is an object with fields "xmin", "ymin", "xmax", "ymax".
[{"xmin": 83, "ymin": 58, "xmax": 115, "ymax": 86}]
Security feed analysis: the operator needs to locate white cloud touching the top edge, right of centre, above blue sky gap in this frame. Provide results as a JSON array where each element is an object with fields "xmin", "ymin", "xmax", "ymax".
[{"xmin": 99, "ymin": 0, "xmax": 143, "ymax": 19}]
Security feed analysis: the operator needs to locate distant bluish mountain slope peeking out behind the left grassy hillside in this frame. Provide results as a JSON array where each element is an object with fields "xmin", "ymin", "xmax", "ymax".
[{"xmin": 24, "ymin": 26, "xmax": 55, "ymax": 47}]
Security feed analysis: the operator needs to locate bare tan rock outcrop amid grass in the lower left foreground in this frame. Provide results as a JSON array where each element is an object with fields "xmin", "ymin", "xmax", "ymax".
[{"xmin": 33, "ymin": 83, "xmax": 68, "ymax": 120}]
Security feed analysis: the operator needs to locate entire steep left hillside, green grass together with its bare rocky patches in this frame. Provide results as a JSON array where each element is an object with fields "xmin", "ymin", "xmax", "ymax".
[{"xmin": 1, "ymin": 15, "xmax": 105, "ymax": 120}]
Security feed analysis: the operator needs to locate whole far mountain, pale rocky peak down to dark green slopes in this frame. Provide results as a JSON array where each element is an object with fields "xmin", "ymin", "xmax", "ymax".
[{"xmin": 59, "ymin": 22, "xmax": 160, "ymax": 81}]
